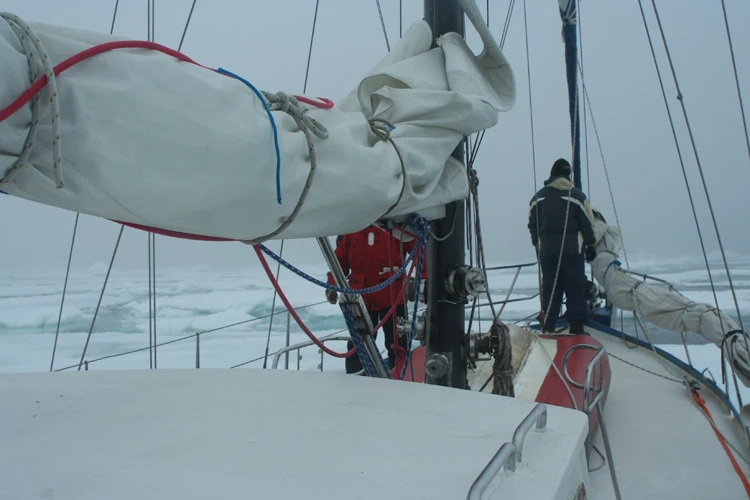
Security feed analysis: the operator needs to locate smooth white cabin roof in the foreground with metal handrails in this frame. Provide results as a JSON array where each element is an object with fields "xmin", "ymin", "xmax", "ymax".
[{"xmin": 0, "ymin": 370, "xmax": 587, "ymax": 500}]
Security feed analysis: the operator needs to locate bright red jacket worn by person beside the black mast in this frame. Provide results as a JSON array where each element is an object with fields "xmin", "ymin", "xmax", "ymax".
[{"xmin": 328, "ymin": 226, "xmax": 427, "ymax": 311}]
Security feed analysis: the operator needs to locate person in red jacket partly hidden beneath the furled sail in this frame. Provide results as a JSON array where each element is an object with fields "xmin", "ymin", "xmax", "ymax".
[{"xmin": 326, "ymin": 225, "xmax": 426, "ymax": 373}]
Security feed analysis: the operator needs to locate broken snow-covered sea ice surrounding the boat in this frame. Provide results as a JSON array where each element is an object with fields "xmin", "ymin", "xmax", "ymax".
[{"xmin": 0, "ymin": 256, "xmax": 750, "ymax": 406}]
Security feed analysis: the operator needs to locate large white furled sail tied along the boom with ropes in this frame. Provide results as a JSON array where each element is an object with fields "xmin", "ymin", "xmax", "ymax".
[{"xmin": 0, "ymin": 17, "xmax": 515, "ymax": 240}]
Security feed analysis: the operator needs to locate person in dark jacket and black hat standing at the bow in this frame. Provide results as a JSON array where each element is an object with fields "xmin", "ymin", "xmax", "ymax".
[{"xmin": 528, "ymin": 158, "xmax": 596, "ymax": 334}]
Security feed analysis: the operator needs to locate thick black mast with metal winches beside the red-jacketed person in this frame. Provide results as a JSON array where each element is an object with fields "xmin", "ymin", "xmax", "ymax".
[{"xmin": 424, "ymin": 0, "xmax": 467, "ymax": 389}]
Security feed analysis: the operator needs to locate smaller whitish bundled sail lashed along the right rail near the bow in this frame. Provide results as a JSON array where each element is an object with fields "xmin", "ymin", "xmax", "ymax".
[{"xmin": 591, "ymin": 220, "xmax": 750, "ymax": 387}]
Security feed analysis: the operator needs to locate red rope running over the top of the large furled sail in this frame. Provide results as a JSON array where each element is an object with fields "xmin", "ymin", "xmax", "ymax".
[{"xmin": 0, "ymin": 40, "xmax": 333, "ymax": 122}]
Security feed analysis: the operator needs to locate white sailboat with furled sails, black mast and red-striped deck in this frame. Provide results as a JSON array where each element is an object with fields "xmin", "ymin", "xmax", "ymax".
[{"xmin": 0, "ymin": 0, "xmax": 750, "ymax": 499}]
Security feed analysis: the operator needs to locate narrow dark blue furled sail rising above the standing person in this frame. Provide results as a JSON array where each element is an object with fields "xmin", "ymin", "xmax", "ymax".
[{"xmin": 559, "ymin": 0, "xmax": 582, "ymax": 189}]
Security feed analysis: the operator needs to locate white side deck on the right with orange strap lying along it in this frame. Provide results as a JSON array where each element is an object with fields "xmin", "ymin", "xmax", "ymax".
[{"xmin": 589, "ymin": 330, "xmax": 750, "ymax": 500}]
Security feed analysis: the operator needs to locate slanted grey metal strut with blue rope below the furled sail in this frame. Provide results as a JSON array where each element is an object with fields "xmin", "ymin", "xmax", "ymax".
[{"xmin": 316, "ymin": 237, "xmax": 391, "ymax": 378}]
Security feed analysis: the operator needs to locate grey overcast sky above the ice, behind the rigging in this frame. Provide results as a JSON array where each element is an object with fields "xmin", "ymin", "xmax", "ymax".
[{"xmin": 0, "ymin": 0, "xmax": 750, "ymax": 275}]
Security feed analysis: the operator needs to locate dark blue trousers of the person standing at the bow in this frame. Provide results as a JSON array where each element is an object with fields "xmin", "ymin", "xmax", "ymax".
[{"xmin": 540, "ymin": 253, "xmax": 586, "ymax": 332}]
